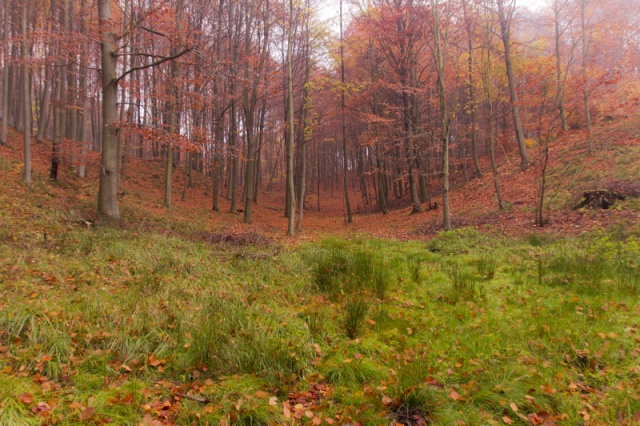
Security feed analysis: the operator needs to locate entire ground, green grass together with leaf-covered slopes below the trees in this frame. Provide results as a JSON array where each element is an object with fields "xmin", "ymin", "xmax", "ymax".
[{"xmin": 0, "ymin": 116, "xmax": 640, "ymax": 425}]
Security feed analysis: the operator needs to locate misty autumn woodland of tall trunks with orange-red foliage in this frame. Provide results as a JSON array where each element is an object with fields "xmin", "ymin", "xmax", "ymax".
[{"xmin": 0, "ymin": 0, "xmax": 640, "ymax": 234}]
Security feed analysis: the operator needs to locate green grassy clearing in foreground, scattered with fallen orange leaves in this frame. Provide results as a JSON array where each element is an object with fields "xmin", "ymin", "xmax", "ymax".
[{"xmin": 0, "ymin": 195, "xmax": 640, "ymax": 425}]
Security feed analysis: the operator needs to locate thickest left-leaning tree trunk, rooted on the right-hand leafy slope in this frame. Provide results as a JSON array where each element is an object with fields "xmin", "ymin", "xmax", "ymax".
[{"xmin": 496, "ymin": 0, "xmax": 529, "ymax": 169}]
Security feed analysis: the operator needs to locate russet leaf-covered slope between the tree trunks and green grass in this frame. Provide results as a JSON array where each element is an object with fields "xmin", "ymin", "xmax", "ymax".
[{"xmin": 0, "ymin": 115, "xmax": 640, "ymax": 240}]
